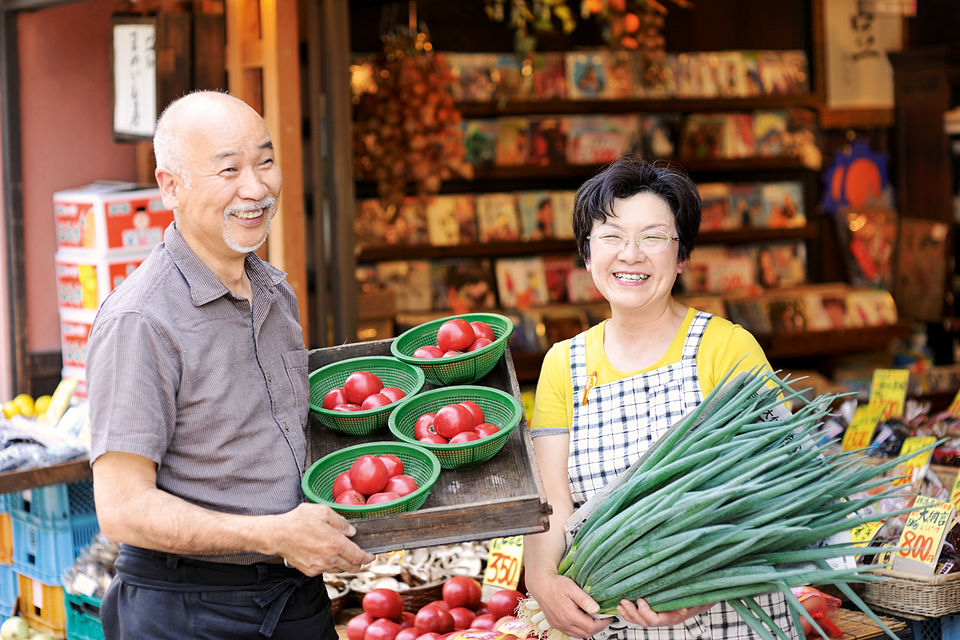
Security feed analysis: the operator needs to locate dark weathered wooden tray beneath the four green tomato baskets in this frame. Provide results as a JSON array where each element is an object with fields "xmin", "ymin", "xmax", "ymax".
[{"xmin": 307, "ymin": 338, "xmax": 550, "ymax": 553}]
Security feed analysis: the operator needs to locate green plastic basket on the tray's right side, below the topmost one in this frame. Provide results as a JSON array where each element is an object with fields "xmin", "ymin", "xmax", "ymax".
[{"xmin": 389, "ymin": 385, "xmax": 523, "ymax": 469}]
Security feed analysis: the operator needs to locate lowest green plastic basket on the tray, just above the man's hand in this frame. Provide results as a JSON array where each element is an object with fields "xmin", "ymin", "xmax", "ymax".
[{"xmin": 300, "ymin": 442, "xmax": 440, "ymax": 518}]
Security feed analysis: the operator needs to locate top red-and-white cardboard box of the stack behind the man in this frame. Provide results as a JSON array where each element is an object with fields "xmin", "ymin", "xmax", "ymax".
[{"xmin": 53, "ymin": 182, "xmax": 173, "ymax": 254}]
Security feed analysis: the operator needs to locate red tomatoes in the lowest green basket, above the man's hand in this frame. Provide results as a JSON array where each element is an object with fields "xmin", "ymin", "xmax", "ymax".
[{"xmin": 332, "ymin": 453, "xmax": 420, "ymax": 505}]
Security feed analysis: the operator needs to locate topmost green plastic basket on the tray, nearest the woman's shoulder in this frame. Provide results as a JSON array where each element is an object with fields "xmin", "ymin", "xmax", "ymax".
[{"xmin": 390, "ymin": 313, "xmax": 513, "ymax": 385}]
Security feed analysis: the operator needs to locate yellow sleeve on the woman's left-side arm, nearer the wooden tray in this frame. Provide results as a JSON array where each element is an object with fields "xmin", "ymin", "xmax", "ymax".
[{"xmin": 530, "ymin": 340, "xmax": 573, "ymax": 438}]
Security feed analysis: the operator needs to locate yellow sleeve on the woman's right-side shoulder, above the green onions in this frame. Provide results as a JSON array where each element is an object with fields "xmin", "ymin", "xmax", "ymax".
[{"xmin": 697, "ymin": 316, "xmax": 770, "ymax": 396}]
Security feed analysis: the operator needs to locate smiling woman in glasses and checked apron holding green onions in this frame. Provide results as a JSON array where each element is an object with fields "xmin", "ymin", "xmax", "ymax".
[{"xmin": 524, "ymin": 156, "xmax": 796, "ymax": 640}]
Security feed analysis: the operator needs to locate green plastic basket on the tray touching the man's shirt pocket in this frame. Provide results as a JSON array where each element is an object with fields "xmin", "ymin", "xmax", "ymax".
[{"xmin": 309, "ymin": 356, "xmax": 425, "ymax": 436}]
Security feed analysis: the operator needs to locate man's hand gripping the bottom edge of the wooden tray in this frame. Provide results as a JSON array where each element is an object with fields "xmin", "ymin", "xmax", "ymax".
[{"xmin": 278, "ymin": 502, "xmax": 375, "ymax": 576}]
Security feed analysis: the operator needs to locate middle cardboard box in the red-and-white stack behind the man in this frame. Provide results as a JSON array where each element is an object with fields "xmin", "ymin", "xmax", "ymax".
[{"xmin": 55, "ymin": 249, "xmax": 149, "ymax": 310}]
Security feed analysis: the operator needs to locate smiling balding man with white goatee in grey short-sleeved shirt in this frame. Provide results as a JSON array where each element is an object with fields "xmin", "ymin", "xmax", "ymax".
[{"xmin": 88, "ymin": 92, "xmax": 373, "ymax": 640}]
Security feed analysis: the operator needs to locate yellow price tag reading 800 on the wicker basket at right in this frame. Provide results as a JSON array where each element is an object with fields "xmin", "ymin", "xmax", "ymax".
[{"xmin": 893, "ymin": 496, "xmax": 956, "ymax": 576}]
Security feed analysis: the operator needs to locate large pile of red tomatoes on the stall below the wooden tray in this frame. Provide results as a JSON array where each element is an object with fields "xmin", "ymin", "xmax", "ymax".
[{"xmin": 347, "ymin": 576, "xmax": 523, "ymax": 640}]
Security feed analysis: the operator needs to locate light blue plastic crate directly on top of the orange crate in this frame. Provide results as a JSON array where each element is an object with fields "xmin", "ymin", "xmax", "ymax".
[{"xmin": 10, "ymin": 513, "xmax": 100, "ymax": 584}]
